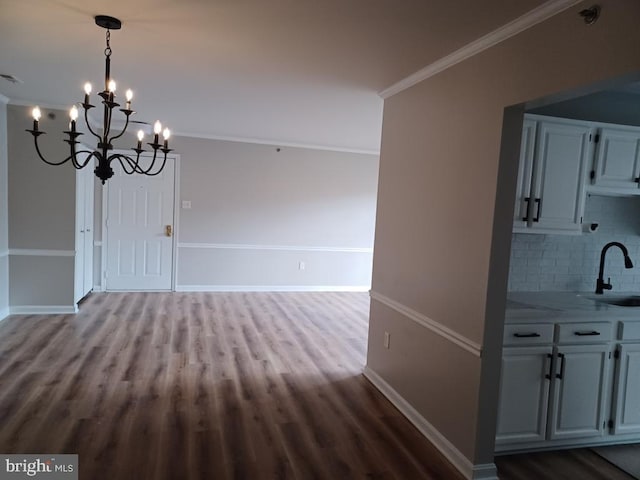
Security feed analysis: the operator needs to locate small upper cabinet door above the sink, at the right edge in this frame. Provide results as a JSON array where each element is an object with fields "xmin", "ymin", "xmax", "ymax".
[{"xmin": 593, "ymin": 128, "xmax": 640, "ymax": 190}]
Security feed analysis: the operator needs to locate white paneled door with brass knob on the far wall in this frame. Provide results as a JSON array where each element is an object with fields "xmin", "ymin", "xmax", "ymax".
[{"xmin": 105, "ymin": 158, "xmax": 175, "ymax": 291}]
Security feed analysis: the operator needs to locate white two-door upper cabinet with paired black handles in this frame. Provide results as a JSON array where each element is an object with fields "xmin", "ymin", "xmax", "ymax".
[{"xmin": 514, "ymin": 115, "xmax": 594, "ymax": 234}]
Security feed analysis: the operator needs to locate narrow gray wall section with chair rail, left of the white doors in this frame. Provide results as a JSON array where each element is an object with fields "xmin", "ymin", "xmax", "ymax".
[{"xmin": 7, "ymin": 105, "xmax": 75, "ymax": 312}]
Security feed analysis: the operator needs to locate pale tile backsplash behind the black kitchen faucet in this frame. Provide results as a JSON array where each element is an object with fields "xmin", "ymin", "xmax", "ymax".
[{"xmin": 509, "ymin": 195, "xmax": 640, "ymax": 294}]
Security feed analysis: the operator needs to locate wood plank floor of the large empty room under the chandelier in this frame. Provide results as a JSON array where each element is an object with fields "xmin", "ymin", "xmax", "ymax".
[{"xmin": 0, "ymin": 293, "xmax": 462, "ymax": 480}]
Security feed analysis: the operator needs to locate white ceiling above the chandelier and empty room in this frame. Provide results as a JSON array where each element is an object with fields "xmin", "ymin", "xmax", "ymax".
[{"xmin": 0, "ymin": 0, "xmax": 544, "ymax": 151}]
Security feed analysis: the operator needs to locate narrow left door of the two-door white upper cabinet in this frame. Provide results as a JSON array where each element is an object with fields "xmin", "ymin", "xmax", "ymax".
[{"xmin": 513, "ymin": 119, "xmax": 537, "ymax": 231}]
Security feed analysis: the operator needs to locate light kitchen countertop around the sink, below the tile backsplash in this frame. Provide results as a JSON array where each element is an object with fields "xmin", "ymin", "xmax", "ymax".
[{"xmin": 505, "ymin": 292, "xmax": 640, "ymax": 323}]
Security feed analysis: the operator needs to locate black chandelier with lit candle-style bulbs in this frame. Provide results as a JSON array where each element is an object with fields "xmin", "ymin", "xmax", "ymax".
[{"xmin": 27, "ymin": 15, "xmax": 171, "ymax": 185}]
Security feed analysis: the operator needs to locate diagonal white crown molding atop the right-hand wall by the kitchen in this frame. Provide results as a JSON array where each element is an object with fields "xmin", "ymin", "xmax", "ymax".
[{"xmin": 379, "ymin": 0, "xmax": 582, "ymax": 98}]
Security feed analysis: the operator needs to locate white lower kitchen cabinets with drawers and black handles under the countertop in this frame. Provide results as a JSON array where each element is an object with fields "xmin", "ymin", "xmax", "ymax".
[{"xmin": 496, "ymin": 321, "xmax": 640, "ymax": 452}]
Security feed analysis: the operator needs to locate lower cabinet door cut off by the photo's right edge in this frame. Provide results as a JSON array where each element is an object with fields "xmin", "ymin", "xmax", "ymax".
[{"xmin": 613, "ymin": 345, "xmax": 640, "ymax": 434}]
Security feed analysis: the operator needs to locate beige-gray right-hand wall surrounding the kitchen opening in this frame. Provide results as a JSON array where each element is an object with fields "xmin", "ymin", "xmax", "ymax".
[{"xmin": 367, "ymin": 0, "xmax": 640, "ymax": 474}]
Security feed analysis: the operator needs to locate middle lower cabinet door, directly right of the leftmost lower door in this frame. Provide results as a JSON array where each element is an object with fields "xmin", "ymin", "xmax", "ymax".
[{"xmin": 549, "ymin": 345, "xmax": 611, "ymax": 439}]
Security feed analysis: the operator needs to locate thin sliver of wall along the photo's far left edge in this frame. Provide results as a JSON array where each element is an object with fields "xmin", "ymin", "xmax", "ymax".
[{"xmin": 0, "ymin": 98, "xmax": 9, "ymax": 320}]
